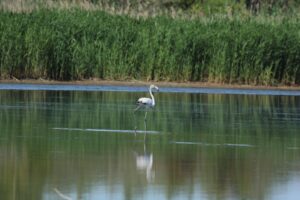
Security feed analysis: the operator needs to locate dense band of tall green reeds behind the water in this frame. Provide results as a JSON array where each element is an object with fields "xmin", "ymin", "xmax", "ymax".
[{"xmin": 0, "ymin": 9, "xmax": 300, "ymax": 85}]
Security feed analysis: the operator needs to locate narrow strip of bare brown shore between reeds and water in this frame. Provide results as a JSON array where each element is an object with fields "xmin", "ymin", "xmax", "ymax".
[{"xmin": 0, "ymin": 79, "xmax": 300, "ymax": 90}]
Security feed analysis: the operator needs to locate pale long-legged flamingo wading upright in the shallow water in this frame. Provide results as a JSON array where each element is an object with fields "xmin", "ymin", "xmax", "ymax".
[{"xmin": 134, "ymin": 85, "xmax": 159, "ymax": 140}]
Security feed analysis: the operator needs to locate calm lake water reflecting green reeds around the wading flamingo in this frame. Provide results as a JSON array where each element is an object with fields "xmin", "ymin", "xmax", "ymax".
[{"xmin": 0, "ymin": 84, "xmax": 300, "ymax": 200}]
